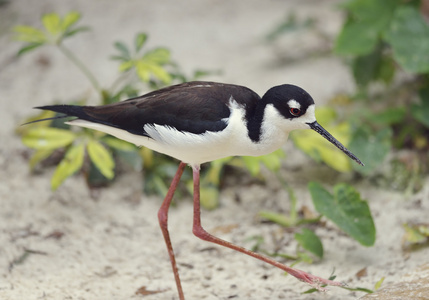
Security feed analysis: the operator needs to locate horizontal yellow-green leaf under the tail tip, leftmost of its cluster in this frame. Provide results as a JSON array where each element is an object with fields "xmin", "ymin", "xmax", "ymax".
[{"xmin": 22, "ymin": 127, "xmax": 76, "ymax": 150}]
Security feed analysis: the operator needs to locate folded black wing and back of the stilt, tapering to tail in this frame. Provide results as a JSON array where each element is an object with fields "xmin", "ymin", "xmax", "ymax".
[{"xmin": 37, "ymin": 81, "xmax": 260, "ymax": 136}]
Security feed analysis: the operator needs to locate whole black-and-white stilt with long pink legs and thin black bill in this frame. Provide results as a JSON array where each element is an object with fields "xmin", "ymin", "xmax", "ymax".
[{"xmin": 33, "ymin": 81, "xmax": 363, "ymax": 300}]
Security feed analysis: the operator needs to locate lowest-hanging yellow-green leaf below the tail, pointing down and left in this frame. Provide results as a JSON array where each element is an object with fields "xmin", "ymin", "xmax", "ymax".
[{"xmin": 51, "ymin": 144, "xmax": 85, "ymax": 190}]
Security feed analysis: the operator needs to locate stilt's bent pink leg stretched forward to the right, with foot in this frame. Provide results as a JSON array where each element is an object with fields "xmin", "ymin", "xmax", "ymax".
[{"xmin": 192, "ymin": 166, "xmax": 344, "ymax": 291}]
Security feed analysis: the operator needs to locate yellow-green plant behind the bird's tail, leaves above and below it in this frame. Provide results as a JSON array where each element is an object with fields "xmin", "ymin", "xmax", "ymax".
[{"xmin": 14, "ymin": 12, "xmax": 206, "ymax": 192}]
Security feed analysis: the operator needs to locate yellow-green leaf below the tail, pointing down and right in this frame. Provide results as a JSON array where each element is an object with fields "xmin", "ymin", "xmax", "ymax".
[{"xmin": 86, "ymin": 140, "xmax": 115, "ymax": 179}]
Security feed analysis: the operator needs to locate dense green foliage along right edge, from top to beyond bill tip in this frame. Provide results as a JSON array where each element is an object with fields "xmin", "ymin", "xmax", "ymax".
[{"xmin": 334, "ymin": 0, "xmax": 429, "ymax": 182}]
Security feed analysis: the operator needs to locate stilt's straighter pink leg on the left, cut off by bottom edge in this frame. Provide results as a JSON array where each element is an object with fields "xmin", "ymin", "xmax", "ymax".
[{"xmin": 158, "ymin": 162, "xmax": 186, "ymax": 300}]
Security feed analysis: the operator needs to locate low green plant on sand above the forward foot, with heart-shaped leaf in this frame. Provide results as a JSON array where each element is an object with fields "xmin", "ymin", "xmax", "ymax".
[{"xmin": 259, "ymin": 182, "xmax": 375, "ymax": 263}]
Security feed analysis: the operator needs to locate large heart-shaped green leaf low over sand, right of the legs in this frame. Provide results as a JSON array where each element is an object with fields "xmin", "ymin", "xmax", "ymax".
[{"xmin": 308, "ymin": 182, "xmax": 375, "ymax": 246}]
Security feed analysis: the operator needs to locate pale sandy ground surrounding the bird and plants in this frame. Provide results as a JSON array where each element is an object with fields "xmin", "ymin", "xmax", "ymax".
[{"xmin": 0, "ymin": 0, "xmax": 429, "ymax": 300}]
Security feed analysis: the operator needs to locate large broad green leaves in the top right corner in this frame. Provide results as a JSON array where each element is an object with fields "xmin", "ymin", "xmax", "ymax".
[{"xmin": 335, "ymin": 0, "xmax": 429, "ymax": 74}]
